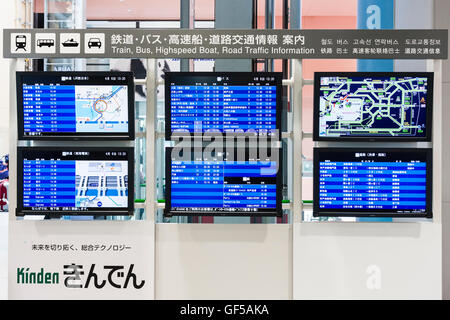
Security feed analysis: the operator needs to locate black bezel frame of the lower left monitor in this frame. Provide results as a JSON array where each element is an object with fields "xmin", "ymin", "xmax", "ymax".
[{"xmin": 16, "ymin": 147, "xmax": 134, "ymax": 217}]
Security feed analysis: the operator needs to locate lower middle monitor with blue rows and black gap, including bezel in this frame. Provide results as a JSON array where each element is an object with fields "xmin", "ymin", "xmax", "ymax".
[{"xmin": 165, "ymin": 148, "xmax": 282, "ymax": 216}]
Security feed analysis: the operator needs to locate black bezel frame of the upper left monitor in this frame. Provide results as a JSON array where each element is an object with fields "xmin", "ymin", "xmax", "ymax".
[{"xmin": 16, "ymin": 71, "xmax": 135, "ymax": 141}]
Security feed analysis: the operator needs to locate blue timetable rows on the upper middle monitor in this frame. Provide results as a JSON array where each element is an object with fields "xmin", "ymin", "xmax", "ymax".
[{"xmin": 170, "ymin": 85, "xmax": 277, "ymax": 133}]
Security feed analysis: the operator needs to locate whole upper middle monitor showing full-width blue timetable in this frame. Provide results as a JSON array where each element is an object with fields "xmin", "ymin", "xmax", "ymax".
[{"xmin": 165, "ymin": 72, "xmax": 282, "ymax": 140}]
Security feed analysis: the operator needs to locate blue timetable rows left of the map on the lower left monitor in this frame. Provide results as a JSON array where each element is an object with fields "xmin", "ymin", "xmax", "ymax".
[{"xmin": 23, "ymin": 160, "xmax": 76, "ymax": 209}]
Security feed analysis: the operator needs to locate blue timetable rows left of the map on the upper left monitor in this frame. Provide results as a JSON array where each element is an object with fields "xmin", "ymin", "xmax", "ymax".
[{"xmin": 23, "ymin": 85, "xmax": 76, "ymax": 133}]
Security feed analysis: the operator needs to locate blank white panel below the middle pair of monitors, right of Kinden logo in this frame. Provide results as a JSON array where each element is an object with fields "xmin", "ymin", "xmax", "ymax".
[{"xmin": 155, "ymin": 223, "xmax": 292, "ymax": 300}]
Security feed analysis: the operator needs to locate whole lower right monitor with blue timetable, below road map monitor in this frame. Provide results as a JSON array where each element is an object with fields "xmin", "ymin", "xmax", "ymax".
[{"xmin": 314, "ymin": 148, "xmax": 432, "ymax": 217}]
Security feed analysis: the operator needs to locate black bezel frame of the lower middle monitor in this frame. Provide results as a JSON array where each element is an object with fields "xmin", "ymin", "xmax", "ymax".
[{"xmin": 164, "ymin": 147, "xmax": 283, "ymax": 217}]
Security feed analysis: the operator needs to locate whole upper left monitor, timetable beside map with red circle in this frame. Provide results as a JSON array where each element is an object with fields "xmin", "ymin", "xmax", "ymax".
[{"xmin": 16, "ymin": 72, "xmax": 134, "ymax": 140}]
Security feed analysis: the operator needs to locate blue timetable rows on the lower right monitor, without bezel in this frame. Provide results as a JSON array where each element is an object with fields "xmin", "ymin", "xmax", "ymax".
[{"xmin": 319, "ymin": 162, "xmax": 426, "ymax": 211}]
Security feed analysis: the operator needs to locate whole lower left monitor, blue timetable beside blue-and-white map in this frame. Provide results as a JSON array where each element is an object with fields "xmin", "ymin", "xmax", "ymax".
[{"xmin": 17, "ymin": 147, "xmax": 134, "ymax": 216}]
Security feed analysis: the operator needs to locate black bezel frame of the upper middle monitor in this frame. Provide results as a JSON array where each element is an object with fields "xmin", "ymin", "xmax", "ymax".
[{"xmin": 164, "ymin": 71, "xmax": 283, "ymax": 141}]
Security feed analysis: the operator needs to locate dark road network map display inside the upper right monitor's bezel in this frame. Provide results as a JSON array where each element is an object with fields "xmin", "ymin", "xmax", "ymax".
[{"xmin": 319, "ymin": 76, "xmax": 429, "ymax": 137}]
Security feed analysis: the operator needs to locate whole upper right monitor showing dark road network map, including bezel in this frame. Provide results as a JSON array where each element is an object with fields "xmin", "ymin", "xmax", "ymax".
[{"xmin": 314, "ymin": 72, "xmax": 433, "ymax": 141}]
